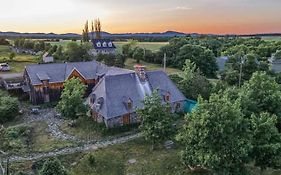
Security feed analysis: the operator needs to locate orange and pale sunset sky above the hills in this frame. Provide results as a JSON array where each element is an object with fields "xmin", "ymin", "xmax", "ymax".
[{"xmin": 0, "ymin": 0, "xmax": 281, "ymax": 34}]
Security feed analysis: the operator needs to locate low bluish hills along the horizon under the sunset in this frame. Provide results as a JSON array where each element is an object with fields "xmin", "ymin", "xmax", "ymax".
[{"xmin": 0, "ymin": 31, "xmax": 281, "ymax": 39}]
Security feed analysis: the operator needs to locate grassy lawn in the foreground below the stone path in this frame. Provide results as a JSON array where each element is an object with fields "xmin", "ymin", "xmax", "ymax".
[{"xmin": 10, "ymin": 138, "xmax": 281, "ymax": 175}]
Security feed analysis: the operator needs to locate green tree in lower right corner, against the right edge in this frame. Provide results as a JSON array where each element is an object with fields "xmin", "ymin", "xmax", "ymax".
[{"xmin": 251, "ymin": 113, "xmax": 281, "ymax": 174}]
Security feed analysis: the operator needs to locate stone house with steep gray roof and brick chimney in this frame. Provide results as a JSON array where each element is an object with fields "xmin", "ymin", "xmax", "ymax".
[{"xmin": 89, "ymin": 66, "xmax": 186, "ymax": 128}]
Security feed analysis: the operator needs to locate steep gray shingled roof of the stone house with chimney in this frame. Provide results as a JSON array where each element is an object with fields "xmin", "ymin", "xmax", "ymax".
[{"xmin": 92, "ymin": 71, "xmax": 186, "ymax": 119}]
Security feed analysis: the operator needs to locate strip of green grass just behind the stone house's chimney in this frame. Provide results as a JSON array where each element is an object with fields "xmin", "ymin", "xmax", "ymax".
[{"xmin": 125, "ymin": 58, "xmax": 181, "ymax": 74}]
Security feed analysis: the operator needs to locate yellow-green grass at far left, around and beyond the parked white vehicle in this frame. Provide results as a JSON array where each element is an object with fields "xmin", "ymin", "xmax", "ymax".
[{"xmin": 0, "ymin": 45, "xmax": 38, "ymax": 74}]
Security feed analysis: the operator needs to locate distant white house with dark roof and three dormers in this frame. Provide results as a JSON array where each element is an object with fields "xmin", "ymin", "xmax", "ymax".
[{"xmin": 90, "ymin": 39, "xmax": 116, "ymax": 56}]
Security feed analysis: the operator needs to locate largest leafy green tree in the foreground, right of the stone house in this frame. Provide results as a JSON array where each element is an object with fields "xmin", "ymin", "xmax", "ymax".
[{"xmin": 177, "ymin": 94, "xmax": 251, "ymax": 175}]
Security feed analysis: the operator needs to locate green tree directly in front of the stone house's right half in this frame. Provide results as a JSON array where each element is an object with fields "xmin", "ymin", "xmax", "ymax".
[{"xmin": 137, "ymin": 91, "xmax": 173, "ymax": 148}]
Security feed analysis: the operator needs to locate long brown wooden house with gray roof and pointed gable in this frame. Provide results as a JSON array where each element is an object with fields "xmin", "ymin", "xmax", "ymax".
[{"xmin": 23, "ymin": 61, "xmax": 128, "ymax": 104}]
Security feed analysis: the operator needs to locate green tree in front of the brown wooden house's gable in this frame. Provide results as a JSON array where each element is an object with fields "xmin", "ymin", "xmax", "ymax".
[{"xmin": 57, "ymin": 78, "xmax": 86, "ymax": 119}]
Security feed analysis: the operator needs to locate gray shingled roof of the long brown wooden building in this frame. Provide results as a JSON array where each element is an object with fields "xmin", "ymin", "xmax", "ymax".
[{"xmin": 26, "ymin": 61, "xmax": 128, "ymax": 85}]
